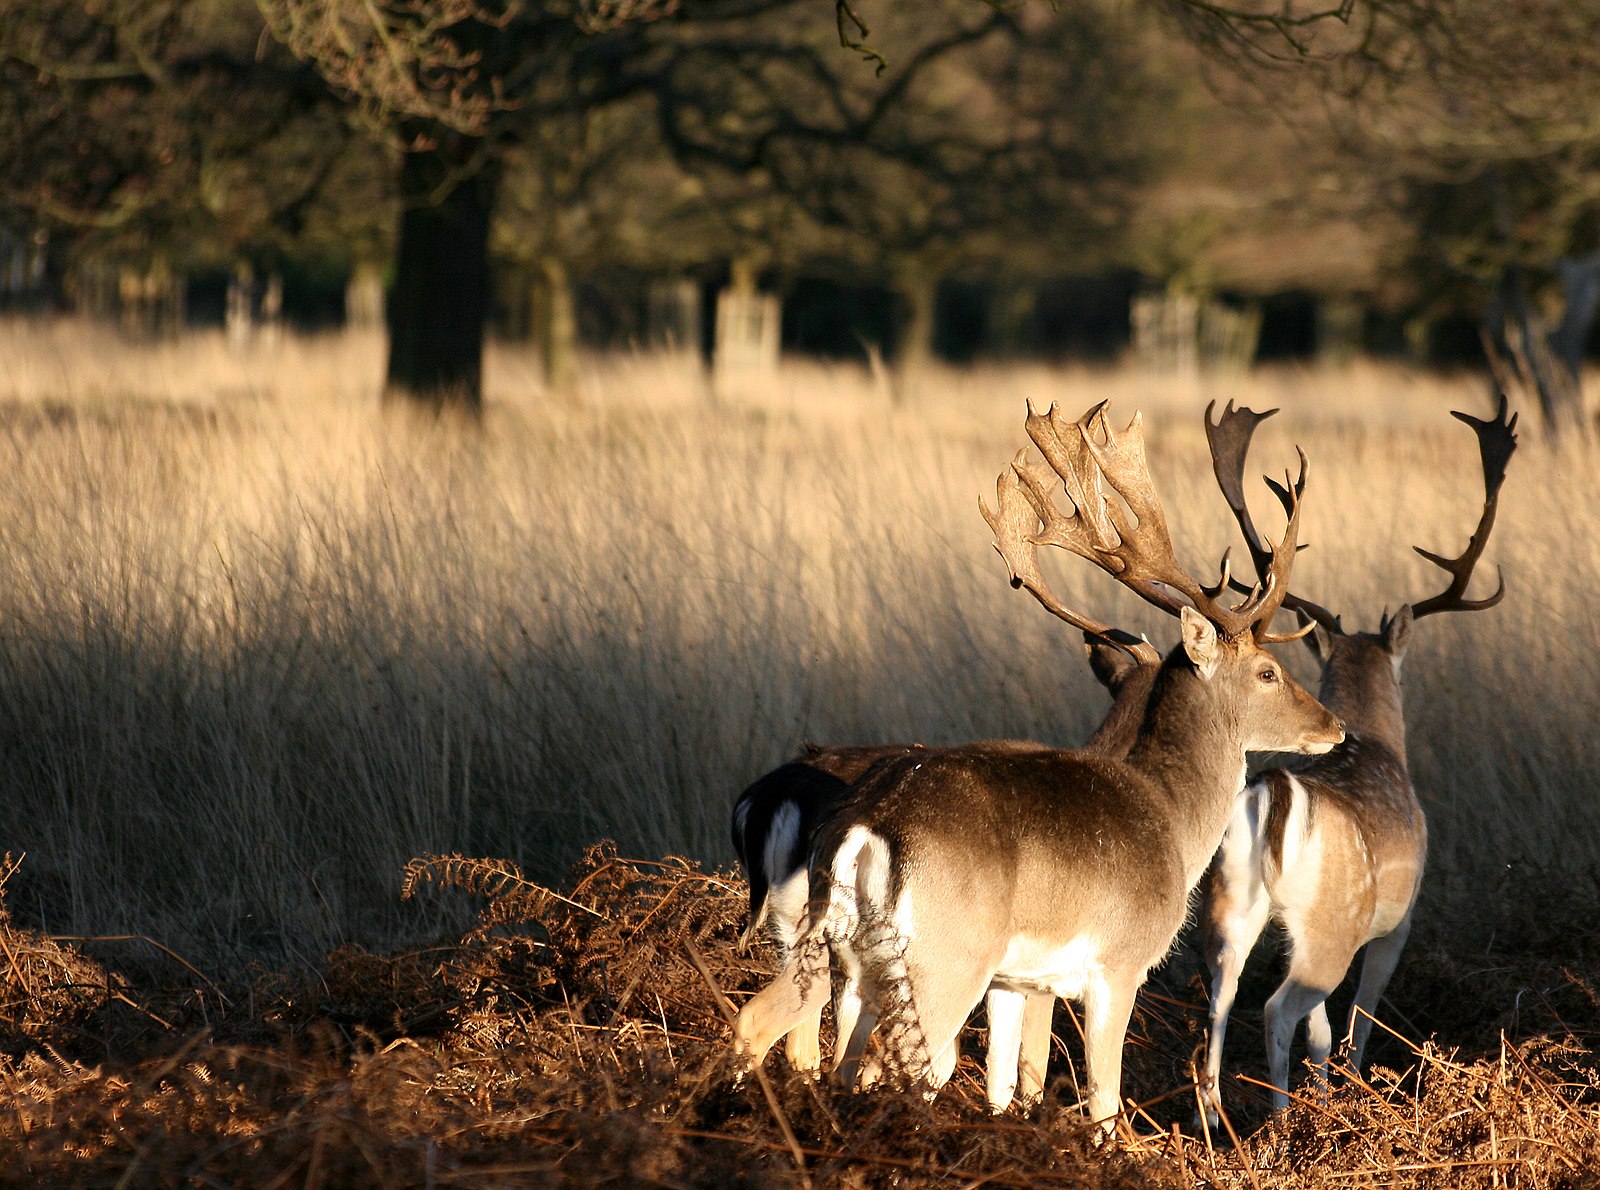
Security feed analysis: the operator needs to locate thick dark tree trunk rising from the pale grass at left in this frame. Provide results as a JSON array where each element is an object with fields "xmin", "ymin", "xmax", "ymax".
[{"xmin": 384, "ymin": 138, "xmax": 498, "ymax": 416}]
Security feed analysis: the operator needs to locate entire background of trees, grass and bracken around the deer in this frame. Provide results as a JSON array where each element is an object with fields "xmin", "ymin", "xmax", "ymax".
[{"xmin": 0, "ymin": 0, "xmax": 1600, "ymax": 1187}]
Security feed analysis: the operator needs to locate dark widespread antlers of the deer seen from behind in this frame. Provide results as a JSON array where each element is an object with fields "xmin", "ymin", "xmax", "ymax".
[{"xmin": 1205, "ymin": 393, "xmax": 1517, "ymax": 632}]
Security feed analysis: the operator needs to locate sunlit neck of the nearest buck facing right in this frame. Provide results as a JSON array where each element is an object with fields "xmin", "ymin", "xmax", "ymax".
[{"xmin": 1128, "ymin": 649, "xmax": 1245, "ymax": 888}]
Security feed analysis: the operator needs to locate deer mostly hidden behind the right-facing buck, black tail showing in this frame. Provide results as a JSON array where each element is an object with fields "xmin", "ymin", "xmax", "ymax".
[{"xmin": 733, "ymin": 632, "xmax": 1162, "ymax": 1110}]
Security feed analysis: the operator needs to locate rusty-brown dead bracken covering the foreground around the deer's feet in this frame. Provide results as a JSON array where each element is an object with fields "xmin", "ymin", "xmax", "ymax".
[{"xmin": 0, "ymin": 845, "xmax": 1600, "ymax": 1188}]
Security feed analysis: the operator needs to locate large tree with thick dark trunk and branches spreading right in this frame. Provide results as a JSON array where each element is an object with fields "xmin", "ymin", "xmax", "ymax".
[{"xmin": 259, "ymin": 0, "xmax": 1152, "ymax": 411}]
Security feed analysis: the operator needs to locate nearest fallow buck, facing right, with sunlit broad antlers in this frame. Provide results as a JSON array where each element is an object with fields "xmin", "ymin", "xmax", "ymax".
[{"xmin": 734, "ymin": 405, "xmax": 1344, "ymax": 1128}]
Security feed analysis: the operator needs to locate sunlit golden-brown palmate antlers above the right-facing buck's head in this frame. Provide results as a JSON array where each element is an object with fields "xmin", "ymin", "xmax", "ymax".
[{"xmin": 979, "ymin": 401, "xmax": 1306, "ymax": 661}]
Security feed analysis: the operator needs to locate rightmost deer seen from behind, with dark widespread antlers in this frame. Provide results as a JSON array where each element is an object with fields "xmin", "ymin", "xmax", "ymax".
[{"xmin": 1202, "ymin": 397, "xmax": 1517, "ymax": 1123}]
